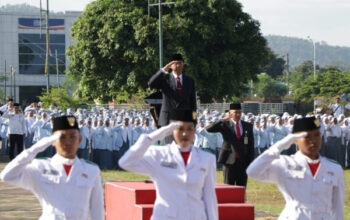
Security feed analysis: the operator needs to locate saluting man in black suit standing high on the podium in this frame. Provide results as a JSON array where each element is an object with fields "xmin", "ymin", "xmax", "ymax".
[{"xmin": 148, "ymin": 54, "xmax": 197, "ymax": 126}]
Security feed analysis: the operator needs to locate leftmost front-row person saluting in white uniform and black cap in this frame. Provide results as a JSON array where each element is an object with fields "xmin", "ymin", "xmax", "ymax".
[{"xmin": 0, "ymin": 116, "xmax": 104, "ymax": 220}]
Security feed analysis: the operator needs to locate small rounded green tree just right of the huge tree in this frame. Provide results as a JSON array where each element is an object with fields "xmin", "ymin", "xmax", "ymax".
[{"xmin": 254, "ymin": 74, "xmax": 287, "ymax": 98}]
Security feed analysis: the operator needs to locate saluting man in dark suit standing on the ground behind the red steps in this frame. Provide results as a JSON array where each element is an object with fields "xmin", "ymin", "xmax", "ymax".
[{"xmin": 206, "ymin": 103, "xmax": 254, "ymax": 186}]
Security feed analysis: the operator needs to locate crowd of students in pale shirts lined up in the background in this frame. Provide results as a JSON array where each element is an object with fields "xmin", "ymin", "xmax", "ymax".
[{"xmin": 0, "ymin": 100, "xmax": 350, "ymax": 169}]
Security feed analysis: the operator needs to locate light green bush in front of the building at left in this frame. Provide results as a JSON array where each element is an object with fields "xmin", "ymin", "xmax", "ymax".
[{"xmin": 39, "ymin": 88, "xmax": 86, "ymax": 109}]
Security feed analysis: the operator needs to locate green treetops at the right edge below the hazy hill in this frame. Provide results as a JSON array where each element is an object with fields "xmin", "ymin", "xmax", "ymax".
[{"xmin": 294, "ymin": 70, "xmax": 350, "ymax": 102}]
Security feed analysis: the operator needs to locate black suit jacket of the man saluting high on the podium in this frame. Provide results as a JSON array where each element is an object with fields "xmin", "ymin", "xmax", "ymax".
[{"xmin": 148, "ymin": 70, "xmax": 197, "ymax": 126}]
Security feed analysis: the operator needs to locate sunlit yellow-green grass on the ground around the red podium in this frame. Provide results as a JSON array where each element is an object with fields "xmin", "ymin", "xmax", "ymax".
[{"xmin": 102, "ymin": 170, "xmax": 350, "ymax": 219}]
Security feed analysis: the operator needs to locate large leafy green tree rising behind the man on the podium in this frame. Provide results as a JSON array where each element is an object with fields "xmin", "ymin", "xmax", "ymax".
[{"xmin": 67, "ymin": 0, "xmax": 268, "ymax": 102}]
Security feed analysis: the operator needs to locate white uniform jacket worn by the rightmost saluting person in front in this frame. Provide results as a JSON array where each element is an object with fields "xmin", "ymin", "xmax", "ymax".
[{"xmin": 247, "ymin": 140, "xmax": 345, "ymax": 220}]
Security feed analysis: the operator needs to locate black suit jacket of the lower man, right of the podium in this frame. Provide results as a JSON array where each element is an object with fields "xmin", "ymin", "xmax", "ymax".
[{"xmin": 206, "ymin": 120, "xmax": 254, "ymax": 167}]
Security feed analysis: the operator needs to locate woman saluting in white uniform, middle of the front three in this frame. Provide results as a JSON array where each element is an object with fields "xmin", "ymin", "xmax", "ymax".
[{"xmin": 119, "ymin": 110, "xmax": 218, "ymax": 220}]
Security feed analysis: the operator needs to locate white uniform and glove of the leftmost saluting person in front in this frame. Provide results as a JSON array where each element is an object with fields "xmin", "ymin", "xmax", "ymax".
[{"xmin": 0, "ymin": 136, "xmax": 104, "ymax": 220}]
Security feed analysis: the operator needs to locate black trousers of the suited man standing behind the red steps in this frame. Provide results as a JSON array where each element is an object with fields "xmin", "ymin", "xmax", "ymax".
[{"xmin": 222, "ymin": 159, "xmax": 248, "ymax": 187}]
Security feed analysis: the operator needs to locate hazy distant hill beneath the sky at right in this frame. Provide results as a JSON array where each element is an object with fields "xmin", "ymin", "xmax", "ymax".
[{"xmin": 265, "ymin": 35, "xmax": 350, "ymax": 69}]
